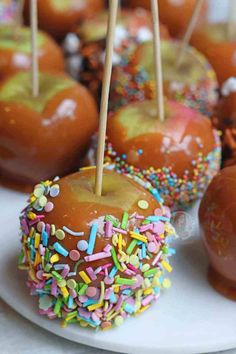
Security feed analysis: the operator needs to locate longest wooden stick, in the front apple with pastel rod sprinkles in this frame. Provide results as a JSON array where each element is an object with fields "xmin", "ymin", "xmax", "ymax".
[{"xmin": 95, "ymin": 0, "xmax": 118, "ymax": 196}]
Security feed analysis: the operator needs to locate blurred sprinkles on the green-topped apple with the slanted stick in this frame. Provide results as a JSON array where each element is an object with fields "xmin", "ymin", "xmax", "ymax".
[{"xmin": 109, "ymin": 41, "xmax": 218, "ymax": 117}]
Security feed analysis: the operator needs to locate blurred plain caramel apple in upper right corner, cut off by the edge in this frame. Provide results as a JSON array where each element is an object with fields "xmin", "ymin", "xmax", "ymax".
[{"xmin": 191, "ymin": 23, "xmax": 236, "ymax": 84}]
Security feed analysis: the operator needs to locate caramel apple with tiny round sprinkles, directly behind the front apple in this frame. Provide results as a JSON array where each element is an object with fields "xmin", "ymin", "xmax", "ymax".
[{"xmin": 105, "ymin": 100, "xmax": 221, "ymax": 208}]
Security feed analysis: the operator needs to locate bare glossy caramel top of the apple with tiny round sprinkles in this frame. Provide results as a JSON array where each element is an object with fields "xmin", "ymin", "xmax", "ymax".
[{"xmin": 107, "ymin": 100, "xmax": 215, "ymax": 176}]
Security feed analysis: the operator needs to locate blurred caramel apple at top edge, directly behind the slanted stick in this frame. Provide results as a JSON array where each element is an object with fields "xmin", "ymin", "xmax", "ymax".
[{"xmin": 124, "ymin": 0, "xmax": 207, "ymax": 37}]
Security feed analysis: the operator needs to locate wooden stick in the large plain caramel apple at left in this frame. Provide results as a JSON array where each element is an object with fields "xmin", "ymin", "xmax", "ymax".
[{"xmin": 30, "ymin": 0, "xmax": 39, "ymax": 97}]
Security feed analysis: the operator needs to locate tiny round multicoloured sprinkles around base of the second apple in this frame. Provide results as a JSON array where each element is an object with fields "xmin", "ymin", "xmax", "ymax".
[{"xmin": 105, "ymin": 130, "xmax": 221, "ymax": 209}]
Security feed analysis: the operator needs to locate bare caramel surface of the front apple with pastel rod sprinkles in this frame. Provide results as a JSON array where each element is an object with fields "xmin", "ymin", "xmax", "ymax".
[{"xmin": 44, "ymin": 168, "xmax": 160, "ymax": 285}]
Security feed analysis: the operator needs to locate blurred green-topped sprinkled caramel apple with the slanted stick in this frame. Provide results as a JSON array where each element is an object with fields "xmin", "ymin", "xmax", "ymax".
[{"xmin": 110, "ymin": 41, "xmax": 218, "ymax": 116}]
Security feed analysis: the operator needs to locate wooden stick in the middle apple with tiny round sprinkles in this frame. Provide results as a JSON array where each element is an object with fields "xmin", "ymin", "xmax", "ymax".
[{"xmin": 151, "ymin": 0, "xmax": 164, "ymax": 122}]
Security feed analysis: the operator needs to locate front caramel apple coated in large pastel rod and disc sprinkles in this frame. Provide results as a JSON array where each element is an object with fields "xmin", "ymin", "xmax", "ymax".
[{"xmin": 19, "ymin": 168, "xmax": 175, "ymax": 329}]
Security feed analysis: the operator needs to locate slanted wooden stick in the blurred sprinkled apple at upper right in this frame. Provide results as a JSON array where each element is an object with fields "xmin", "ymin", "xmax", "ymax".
[{"xmin": 176, "ymin": 0, "xmax": 204, "ymax": 68}]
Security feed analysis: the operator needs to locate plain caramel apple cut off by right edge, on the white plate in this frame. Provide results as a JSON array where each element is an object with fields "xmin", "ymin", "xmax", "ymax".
[{"xmin": 199, "ymin": 166, "xmax": 236, "ymax": 300}]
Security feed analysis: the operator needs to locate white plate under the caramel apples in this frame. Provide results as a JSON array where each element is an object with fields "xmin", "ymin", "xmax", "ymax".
[{"xmin": 0, "ymin": 188, "xmax": 236, "ymax": 354}]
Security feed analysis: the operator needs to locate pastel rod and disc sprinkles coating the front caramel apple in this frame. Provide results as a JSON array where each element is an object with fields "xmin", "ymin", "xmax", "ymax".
[{"xmin": 19, "ymin": 179, "xmax": 176, "ymax": 330}]
